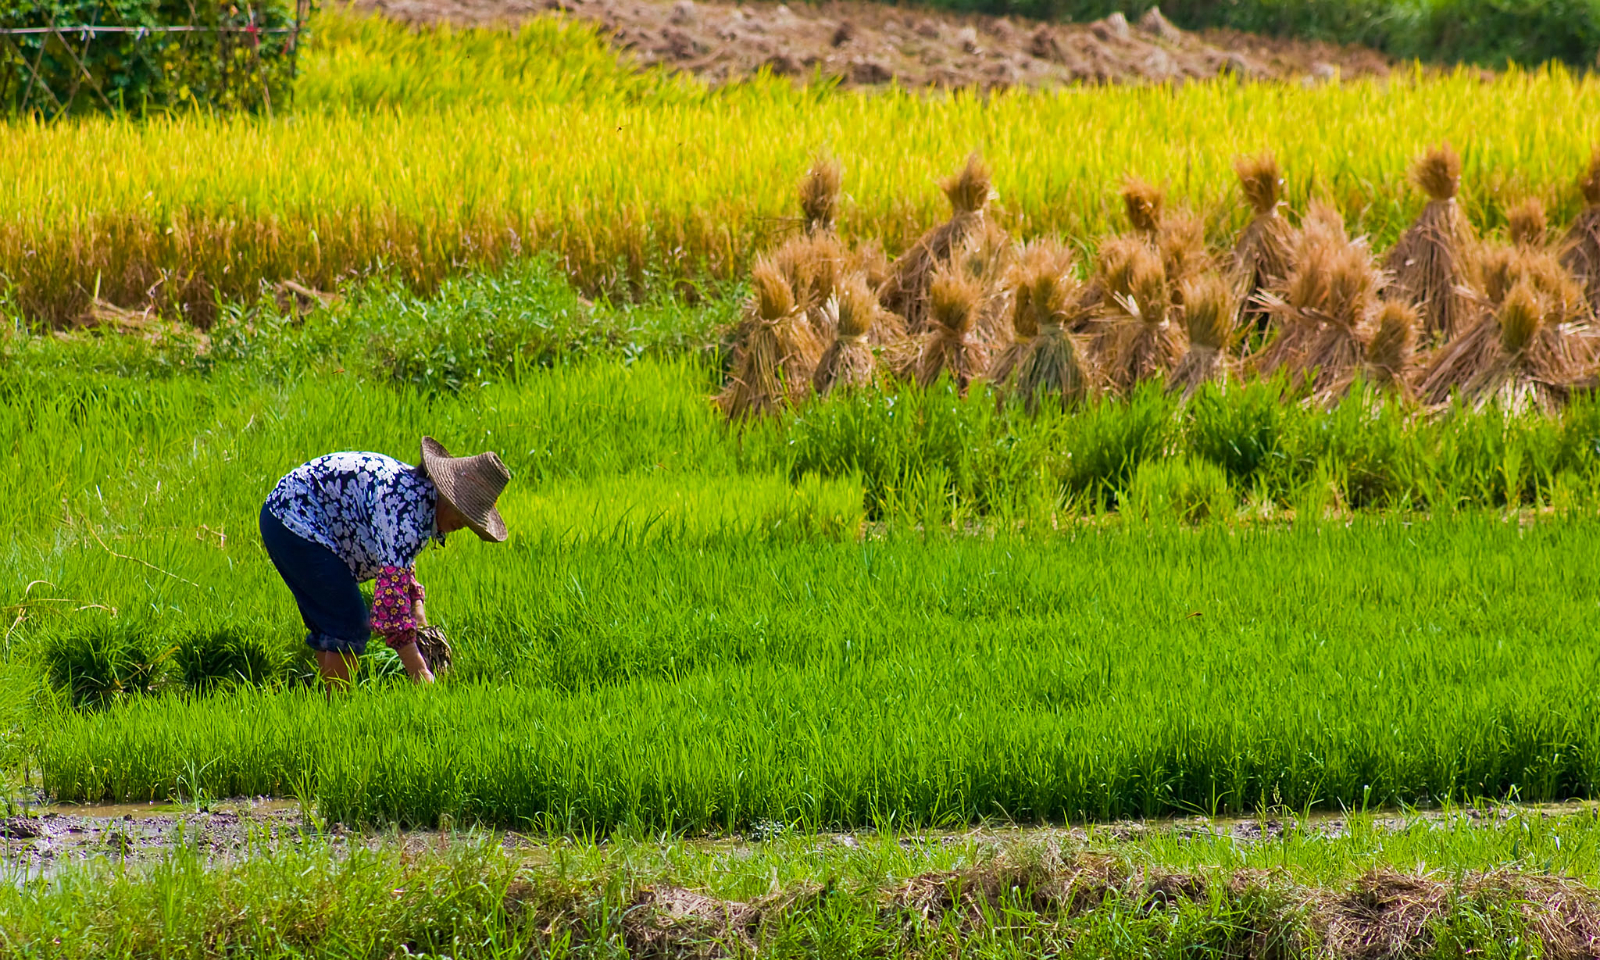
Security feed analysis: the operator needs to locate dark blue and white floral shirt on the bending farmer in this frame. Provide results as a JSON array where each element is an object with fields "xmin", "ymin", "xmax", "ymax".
[{"xmin": 267, "ymin": 453, "xmax": 440, "ymax": 582}]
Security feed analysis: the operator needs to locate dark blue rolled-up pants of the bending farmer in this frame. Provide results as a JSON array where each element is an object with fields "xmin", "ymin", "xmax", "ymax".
[{"xmin": 261, "ymin": 507, "xmax": 373, "ymax": 656}]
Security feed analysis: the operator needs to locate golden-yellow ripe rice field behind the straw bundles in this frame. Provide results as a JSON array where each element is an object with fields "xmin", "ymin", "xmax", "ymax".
[{"xmin": 0, "ymin": 13, "xmax": 1600, "ymax": 323}]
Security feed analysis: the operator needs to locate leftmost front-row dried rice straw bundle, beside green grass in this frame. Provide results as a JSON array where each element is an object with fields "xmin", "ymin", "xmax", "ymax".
[{"xmin": 717, "ymin": 258, "xmax": 822, "ymax": 421}]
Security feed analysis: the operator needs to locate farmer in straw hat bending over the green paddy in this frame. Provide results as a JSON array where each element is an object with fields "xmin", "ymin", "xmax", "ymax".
[{"xmin": 261, "ymin": 437, "xmax": 510, "ymax": 690}]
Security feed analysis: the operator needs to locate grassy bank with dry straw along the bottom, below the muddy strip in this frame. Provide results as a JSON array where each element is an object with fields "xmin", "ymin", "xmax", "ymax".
[{"xmin": 9, "ymin": 810, "xmax": 1600, "ymax": 960}]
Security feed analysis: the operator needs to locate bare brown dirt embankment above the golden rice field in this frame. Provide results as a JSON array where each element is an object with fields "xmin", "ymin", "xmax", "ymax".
[{"xmin": 357, "ymin": 0, "xmax": 1390, "ymax": 90}]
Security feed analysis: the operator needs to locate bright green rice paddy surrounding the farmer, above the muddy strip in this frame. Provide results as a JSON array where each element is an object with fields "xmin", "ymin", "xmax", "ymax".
[{"xmin": 9, "ymin": 296, "xmax": 1600, "ymax": 832}]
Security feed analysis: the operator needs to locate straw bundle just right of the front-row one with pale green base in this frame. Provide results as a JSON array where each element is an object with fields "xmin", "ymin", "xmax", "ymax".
[{"xmin": 1096, "ymin": 248, "xmax": 1184, "ymax": 392}]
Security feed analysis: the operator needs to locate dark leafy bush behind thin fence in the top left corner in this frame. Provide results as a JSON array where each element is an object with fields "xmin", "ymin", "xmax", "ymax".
[{"xmin": 0, "ymin": 0, "xmax": 296, "ymax": 117}]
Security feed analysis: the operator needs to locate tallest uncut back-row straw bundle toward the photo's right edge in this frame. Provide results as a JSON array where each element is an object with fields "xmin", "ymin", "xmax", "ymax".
[{"xmin": 1389, "ymin": 144, "xmax": 1474, "ymax": 341}]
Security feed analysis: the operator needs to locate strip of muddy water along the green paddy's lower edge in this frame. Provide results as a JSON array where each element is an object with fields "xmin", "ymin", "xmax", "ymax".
[{"xmin": 0, "ymin": 797, "xmax": 1600, "ymax": 883}]
